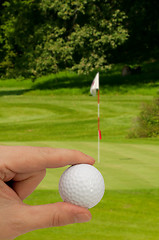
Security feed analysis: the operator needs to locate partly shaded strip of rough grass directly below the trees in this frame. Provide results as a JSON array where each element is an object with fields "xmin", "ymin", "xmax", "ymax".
[{"xmin": 0, "ymin": 61, "xmax": 159, "ymax": 96}]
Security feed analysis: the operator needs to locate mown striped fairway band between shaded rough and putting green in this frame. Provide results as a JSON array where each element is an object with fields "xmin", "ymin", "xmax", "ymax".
[{"xmin": 0, "ymin": 95, "xmax": 157, "ymax": 142}]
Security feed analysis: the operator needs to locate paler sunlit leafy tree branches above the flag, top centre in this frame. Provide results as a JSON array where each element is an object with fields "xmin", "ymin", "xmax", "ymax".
[{"xmin": 35, "ymin": 0, "xmax": 127, "ymax": 73}]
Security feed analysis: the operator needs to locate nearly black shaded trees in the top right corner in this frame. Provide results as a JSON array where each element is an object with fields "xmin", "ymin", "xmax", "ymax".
[{"xmin": 112, "ymin": 0, "xmax": 159, "ymax": 62}]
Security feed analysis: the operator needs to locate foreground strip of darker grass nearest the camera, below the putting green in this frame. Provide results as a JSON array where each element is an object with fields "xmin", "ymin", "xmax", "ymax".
[{"xmin": 14, "ymin": 190, "xmax": 159, "ymax": 240}]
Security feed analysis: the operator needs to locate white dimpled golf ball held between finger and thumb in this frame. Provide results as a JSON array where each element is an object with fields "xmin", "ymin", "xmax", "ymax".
[{"xmin": 59, "ymin": 164, "xmax": 105, "ymax": 208}]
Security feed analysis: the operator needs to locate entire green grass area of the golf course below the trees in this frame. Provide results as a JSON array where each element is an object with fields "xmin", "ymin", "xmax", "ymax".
[{"xmin": 0, "ymin": 62, "xmax": 159, "ymax": 240}]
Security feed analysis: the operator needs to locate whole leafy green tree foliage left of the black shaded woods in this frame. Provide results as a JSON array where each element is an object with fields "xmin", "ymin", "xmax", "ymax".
[{"xmin": 0, "ymin": 0, "xmax": 128, "ymax": 77}]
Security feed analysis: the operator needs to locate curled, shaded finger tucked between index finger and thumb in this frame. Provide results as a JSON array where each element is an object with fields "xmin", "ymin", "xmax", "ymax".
[{"xmin": 12, "ymin": 170, "xmax": 46, "ymax": 200}]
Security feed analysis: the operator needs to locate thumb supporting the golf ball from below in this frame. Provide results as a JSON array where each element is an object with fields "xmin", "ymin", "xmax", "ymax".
[{"xmin": 14, "ymin": 203, "xmax": 91, "ymax": 235}]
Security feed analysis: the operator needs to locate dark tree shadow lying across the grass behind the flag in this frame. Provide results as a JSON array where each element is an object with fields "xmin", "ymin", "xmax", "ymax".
[{"xmin": 0, "ymin": 61, "xmax": 159, "ymax": 97}]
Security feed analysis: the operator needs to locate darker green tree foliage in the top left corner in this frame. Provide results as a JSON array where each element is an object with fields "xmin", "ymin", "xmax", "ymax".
[{"xmin": 0, "ymin": 0, "xmax": 41, "ymax": 77}]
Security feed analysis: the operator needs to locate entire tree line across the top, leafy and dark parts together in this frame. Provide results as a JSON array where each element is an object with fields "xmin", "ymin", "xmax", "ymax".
[{"xmin": 0, "ymin": 0, "xmax": 159, "ymax": 78}]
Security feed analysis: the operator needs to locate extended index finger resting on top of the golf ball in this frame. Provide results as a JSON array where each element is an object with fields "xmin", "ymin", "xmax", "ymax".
[{"xmin": 0, "ymin": 146, "xmax": 95, "ymax": 173}]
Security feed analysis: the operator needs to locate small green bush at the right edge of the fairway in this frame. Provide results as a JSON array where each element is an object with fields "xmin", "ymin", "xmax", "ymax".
[{"xmin": 129, "ymin": 98, "xmax": 159, "ymax": 138}]
